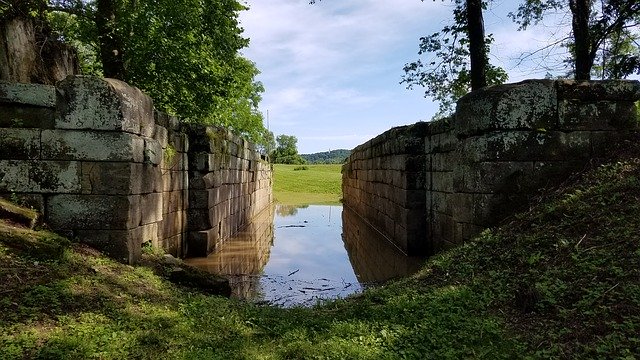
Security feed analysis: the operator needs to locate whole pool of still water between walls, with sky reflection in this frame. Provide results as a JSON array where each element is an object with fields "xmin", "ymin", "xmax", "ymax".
[{"xmin": 187, "ymin": 205, "xmax": 422, "ymax": 306}]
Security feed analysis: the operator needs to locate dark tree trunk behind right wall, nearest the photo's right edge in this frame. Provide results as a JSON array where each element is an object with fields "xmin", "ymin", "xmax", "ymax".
[{"xmin": 569, "ymin": 0, "xmax": 593, "ymax": 80}]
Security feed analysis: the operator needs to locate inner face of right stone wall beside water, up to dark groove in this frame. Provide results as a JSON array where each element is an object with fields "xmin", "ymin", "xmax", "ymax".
[{"xmin": 342, "ymin": 123, "xmax": 429, "ymax": 253}]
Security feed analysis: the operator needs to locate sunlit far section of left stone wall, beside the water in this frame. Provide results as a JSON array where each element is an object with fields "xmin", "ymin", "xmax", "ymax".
[{"xmin": 187, "ymin": 127, "xmax": 272, "ymax": 256}]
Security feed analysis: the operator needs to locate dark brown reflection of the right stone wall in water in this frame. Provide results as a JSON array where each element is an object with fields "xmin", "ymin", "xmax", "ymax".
[{"xmin": 342, "ymin": 206, "xmax": 424, "ymax": 283}]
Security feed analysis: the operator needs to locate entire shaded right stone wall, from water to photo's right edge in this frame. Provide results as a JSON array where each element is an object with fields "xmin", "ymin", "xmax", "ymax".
[{"xmin": 343, "ymin": 80, "xmax": 640, "ymax": 255}]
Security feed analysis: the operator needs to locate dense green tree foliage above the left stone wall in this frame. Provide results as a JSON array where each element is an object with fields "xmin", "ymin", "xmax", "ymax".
[{"xmin": 0, "ymin": 0, "xmax": 266, "ymax": 143}]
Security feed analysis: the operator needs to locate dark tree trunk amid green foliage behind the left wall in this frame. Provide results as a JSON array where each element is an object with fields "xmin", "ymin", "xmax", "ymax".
[{"xmin": 96, "ymin": 0, "xmax": 125, "ymax": 80}]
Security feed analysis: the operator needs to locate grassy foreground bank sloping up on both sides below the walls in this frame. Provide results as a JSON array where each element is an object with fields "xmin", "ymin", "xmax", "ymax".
[{"xmin": 0, "ymin": 151, "xmax": 640, "ymax": 359}]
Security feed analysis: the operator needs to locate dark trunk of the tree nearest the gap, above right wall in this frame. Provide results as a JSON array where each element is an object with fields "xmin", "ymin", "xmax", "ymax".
[{"xmin": 467, "ymin": 0, "xmax": 487, "ymax": 91}]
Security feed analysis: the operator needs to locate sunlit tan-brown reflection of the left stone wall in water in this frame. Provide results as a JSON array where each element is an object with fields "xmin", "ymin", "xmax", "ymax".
[{"xmin": 187, "ymin": 206, "xmax": 274, "ymax": 299}]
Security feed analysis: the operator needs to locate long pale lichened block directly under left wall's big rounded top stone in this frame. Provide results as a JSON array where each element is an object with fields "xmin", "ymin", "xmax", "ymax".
[{"xmin": 42, "ymin": 130, "xmax": 145, "ymax": 163}]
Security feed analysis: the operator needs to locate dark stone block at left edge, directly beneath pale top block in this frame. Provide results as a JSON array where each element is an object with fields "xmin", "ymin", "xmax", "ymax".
[{"xmin": 0, "ymin": 102, "xmax": 55, "ymax": 129}]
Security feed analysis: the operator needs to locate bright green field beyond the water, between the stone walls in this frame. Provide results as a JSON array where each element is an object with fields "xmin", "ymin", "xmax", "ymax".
[{"xmin": 273, "ymin": 164, "xmax": 342, "ymax": 205}]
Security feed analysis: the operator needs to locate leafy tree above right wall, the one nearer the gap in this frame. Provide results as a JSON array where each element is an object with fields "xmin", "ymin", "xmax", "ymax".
[{"xmin": 401, "ymin": 0, "xmax": 508, "ymax": 118}]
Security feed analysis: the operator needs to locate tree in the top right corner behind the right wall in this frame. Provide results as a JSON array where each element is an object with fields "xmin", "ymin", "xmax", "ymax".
[{"xmin": 510, "ymin": 0, "xmax": 640, "ymax": 80}]
